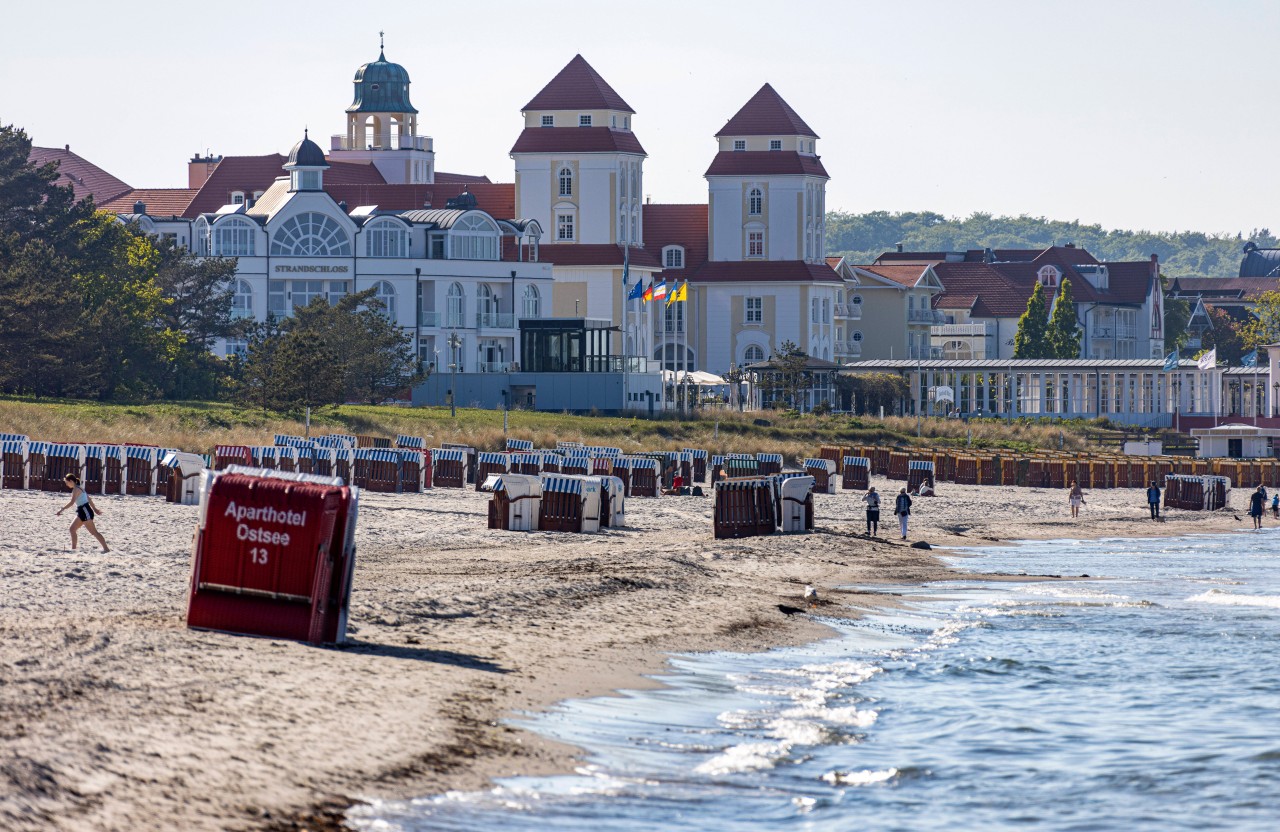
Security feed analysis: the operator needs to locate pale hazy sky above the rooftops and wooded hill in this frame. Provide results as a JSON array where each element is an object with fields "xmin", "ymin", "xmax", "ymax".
[{"xmin": 0, "ymin": 0, "xmax": 1280, "ymax": 232}]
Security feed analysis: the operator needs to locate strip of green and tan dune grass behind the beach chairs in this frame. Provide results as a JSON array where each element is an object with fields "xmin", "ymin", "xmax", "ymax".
[{"xmin": 0, "ymin": 398, "xmax": 1126, "ymax": 461}]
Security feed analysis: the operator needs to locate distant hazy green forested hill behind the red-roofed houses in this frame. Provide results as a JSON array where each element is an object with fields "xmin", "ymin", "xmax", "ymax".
[{"xmin": 827, "ymin": 211, "xmax": 1280, "ymax": 278}]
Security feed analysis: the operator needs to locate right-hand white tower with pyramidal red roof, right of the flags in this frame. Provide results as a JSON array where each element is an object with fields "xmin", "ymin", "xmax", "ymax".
[{"xmin": 705, "ymin": 84, "xmax": 829, "ymax": 264}]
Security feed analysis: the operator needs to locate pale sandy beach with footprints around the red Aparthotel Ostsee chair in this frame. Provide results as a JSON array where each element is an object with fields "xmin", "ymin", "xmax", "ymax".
[{"xmin": 0, "ymin": 480, "xmax": 1248, "ymax": 832}]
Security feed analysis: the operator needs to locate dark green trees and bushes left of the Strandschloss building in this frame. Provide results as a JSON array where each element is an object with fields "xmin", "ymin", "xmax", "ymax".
[{"xmin": 0, "ymin": 124, "xmax": 422, "ymax": 411}]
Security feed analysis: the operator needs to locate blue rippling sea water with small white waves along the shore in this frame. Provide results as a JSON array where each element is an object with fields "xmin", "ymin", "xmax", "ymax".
[{"xmin": 353, "ymin": 531, "xmax": 1280, "ymax": 832}]
